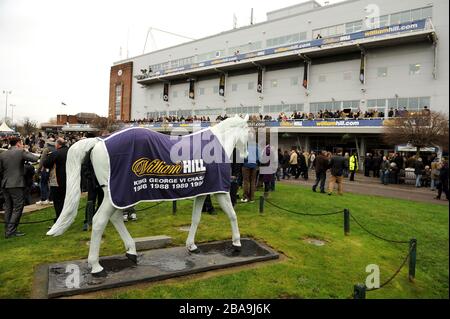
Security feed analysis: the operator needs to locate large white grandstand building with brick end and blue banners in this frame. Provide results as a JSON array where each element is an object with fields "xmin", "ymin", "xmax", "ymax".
[{"xmin": 109, "ymin": 0, "xmax": 449, "ymax": 154}]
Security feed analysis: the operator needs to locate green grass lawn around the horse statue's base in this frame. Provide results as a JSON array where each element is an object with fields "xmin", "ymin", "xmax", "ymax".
[{"xmin": 0, "ymin": 184, "xmax": 449, "ymax": 298}]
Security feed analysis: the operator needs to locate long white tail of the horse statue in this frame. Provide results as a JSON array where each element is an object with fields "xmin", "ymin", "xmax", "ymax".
[{"xmin": 47, "ymin": 138, "xmax": 98, "ymax": 236}]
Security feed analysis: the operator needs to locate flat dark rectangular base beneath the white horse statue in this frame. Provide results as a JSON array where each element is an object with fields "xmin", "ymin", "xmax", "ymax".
[{"xmin": 39, "ymin": 239, "xmax": 279, "ymax": 298}]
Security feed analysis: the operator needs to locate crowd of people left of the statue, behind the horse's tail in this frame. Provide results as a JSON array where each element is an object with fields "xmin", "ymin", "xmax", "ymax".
[{"xmin": 0, "ymin": 133, "xmax": 137, "ymax": 238}]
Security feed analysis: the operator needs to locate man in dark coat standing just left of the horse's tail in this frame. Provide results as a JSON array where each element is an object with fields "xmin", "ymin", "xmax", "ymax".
[{"xmin": 44, "ymin": 138, "xmax": 69, "ymax": 222}]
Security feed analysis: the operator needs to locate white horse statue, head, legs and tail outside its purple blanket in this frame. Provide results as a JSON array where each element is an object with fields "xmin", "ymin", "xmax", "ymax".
[{"xmin": 47, "ymin": 115, "xmax": 248, "ymax": 277}]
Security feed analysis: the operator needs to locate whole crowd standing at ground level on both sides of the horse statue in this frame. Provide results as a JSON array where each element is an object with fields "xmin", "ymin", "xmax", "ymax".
[{"xmin": 0, "ymin": 124, "xmax": 449, "ymax": 238}]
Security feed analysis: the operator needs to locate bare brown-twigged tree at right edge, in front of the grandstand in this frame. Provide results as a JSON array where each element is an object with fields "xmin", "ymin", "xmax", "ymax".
[{"xmin": 383, "ymin": 111, "xmax": 449, "ymax": 153}]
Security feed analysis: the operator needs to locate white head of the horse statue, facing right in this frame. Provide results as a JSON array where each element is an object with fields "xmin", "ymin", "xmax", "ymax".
[{"xmin": 211, "ymin": 114, "xmax": 249, "ymax": 157}]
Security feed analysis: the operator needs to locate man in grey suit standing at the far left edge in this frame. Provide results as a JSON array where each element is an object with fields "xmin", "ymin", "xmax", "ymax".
[{"xmin": 0, "ymin": 137, "xmax": 39, "ymax": 238}]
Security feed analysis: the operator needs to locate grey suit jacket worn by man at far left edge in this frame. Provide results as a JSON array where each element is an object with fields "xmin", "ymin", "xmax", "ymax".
[{"xmin": 0, "ymin": 146, "xmax": 39, "ymax": 188}]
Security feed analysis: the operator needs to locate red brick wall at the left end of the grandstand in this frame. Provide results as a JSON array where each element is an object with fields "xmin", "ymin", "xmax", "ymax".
[{"xmin": 108, "ymin": 62, "xmax": 133, "ymax": 121}]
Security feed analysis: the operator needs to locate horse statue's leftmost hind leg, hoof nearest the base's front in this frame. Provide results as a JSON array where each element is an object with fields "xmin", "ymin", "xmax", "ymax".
[{"xmin": 88, "ymin": 196, "xmax": 116, "ymax": 277}]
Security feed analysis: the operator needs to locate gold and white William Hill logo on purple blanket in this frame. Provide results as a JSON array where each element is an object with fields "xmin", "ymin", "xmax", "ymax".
[{"xmin": 131, "ymin": 157, "xmax": 206, "ymax": 177}]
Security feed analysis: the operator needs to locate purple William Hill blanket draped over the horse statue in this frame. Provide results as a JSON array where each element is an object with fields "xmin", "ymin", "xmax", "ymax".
[{"xmin": 103, "ymin": 128, "xmax": 231, "ymax": 209}]
